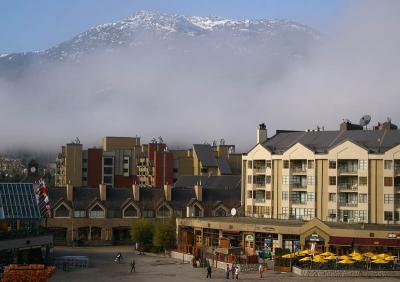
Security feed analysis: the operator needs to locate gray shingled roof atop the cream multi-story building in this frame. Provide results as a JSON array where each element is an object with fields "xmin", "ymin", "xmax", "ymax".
[{"xmin": 262, "ymin": 130, "xmax": 400, "ymax": 154}]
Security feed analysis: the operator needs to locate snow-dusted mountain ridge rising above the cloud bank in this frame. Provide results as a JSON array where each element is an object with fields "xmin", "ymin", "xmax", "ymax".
[{"xmin": 0, "ymin": 11, "xmax": 320, "ymax": 78}]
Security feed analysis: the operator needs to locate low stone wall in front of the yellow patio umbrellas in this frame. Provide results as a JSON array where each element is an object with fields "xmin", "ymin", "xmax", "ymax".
[{"xmin": 293, "ymin": 266, "xmax": 400, "ymax": 277}]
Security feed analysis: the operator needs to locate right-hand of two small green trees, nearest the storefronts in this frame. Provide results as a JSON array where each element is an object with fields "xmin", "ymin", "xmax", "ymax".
[{"xmin": 153, "ymin": 219, "xmax": 176, "ymax": 250}]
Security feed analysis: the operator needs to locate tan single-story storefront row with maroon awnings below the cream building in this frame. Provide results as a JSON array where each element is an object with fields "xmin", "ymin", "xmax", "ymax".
[{"xmin": 177, "ymin": 217, "xmax": 400, "ymax": 256}]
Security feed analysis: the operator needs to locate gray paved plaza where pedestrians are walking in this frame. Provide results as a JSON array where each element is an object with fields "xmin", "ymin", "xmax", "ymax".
[{"xmin": 49, "ymin": 246, "xmax": 400, "ymax": 282}]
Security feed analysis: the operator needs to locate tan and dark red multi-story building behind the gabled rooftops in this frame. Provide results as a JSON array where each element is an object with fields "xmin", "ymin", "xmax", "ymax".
[{"xmin": 56, "ymin": 137, "xmax": 173, "ymax": 187}]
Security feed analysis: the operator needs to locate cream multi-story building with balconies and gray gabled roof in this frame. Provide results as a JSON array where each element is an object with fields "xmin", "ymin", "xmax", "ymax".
[{"xmin": 242, "ymin": 121, "xmax": 400, "ymax": 224}]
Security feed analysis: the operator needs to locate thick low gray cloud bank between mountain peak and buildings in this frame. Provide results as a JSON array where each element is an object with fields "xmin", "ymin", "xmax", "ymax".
[{"xmin": 0, "ymin": 1, "xmax": 400, "ymax": 154}]
